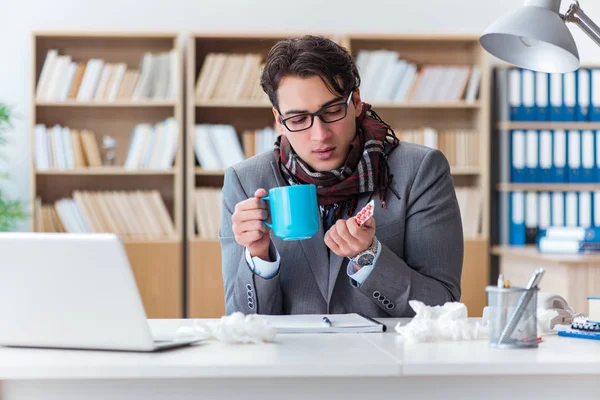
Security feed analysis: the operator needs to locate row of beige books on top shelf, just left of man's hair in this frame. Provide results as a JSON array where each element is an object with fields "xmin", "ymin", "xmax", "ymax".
[{"xmin": 196, "ymin": 53, "xmax": 268, "ymax": 103}]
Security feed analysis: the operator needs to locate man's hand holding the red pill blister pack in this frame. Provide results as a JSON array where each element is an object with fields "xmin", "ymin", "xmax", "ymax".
[{"xmin": 325, "ymin": 218, "xmax": 375, "ymax": 257}]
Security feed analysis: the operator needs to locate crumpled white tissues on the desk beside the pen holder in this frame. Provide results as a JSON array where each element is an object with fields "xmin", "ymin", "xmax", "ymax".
[{"xmin": 394, "ymin": 300, "xmax": 488, "ymax": 342}]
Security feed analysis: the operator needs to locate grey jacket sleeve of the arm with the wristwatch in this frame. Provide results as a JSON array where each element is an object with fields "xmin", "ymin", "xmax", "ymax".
[{"xmin": 358, "ymin": 150, "xmax": 464, "ymax": 317}]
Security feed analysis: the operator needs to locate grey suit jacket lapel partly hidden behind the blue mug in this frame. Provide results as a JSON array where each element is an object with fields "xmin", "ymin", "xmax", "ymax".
[{"xmin": 271, "ymin": 161, "xmax": 328, "ymax": 299}]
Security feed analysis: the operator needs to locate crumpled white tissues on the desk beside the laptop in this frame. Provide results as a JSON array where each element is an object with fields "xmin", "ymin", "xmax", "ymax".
[{"xmin": 177, "ymin": 312, "xmax": 277, "ymax": 343}]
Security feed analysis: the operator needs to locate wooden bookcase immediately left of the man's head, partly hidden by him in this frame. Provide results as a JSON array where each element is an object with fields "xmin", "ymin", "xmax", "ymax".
[{"xmin": 186, "ymin": 33, "xmax": 300, "ymax": 318}]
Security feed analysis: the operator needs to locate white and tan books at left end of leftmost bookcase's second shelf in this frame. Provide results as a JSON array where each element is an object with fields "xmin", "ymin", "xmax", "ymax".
[{"xmin": 34, "ymin": 124, "xmax": 102, "ymax": 171}]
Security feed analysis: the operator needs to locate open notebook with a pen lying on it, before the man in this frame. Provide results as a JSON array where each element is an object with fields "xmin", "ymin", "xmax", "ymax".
[{"xmin": 263, "ymin": 313, "xmax": 386, "ymax": 333}]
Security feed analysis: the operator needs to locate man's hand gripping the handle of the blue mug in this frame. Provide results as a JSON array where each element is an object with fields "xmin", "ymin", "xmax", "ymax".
[{"xmin": 231, "ymin": 189, "xmax": 271, "ymax": 261}]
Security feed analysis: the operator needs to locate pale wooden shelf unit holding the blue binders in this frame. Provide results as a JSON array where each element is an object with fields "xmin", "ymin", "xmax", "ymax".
[{"xmin": 491, "ymin": 63, "xmax": 600, "ymax": 313}]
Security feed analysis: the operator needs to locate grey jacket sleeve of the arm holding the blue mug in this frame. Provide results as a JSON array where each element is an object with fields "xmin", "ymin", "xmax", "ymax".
[{"xmin": 219, "ymin": 167, "xmax": 282, "ymax": 315}]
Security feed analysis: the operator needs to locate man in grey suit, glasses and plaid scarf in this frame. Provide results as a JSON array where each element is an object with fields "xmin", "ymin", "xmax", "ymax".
[{"xmin": 219, "ymin": 36, "xmax": 463, "ymax": 317}]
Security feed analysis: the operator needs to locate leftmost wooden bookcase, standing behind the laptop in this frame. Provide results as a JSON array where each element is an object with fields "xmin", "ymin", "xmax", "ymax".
[{"xmin": 31, "ymin": 32, "xmax": 184, "ymax": 318}]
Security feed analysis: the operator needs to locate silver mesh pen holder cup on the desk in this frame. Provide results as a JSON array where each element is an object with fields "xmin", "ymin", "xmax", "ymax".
[{"xmin": 485, "ymin": 286, "xmax": 539, "ymax": 348}]
